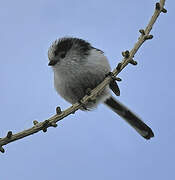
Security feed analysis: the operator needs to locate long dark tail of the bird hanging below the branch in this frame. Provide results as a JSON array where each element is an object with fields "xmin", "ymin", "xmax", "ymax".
[{"xmin": 104, "ymin": 97, "xmax": 154, "ymax": 139}]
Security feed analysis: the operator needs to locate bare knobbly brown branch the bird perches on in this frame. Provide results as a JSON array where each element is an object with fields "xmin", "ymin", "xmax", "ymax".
[{"xmin": 0, "ymin": 0, "xmax": 166, "ymax": 153}]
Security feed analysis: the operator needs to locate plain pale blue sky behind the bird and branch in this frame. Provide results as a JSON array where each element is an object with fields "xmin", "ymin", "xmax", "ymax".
[{"xmin": 0, "ymin": 0, "xmax": 175, "ymax": 180}]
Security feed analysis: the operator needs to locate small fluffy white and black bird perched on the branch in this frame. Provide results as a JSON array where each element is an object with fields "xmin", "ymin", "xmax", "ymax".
[{"xmin": 48, "ymin": 37, "xmax": 154, "ymax": 139}]
